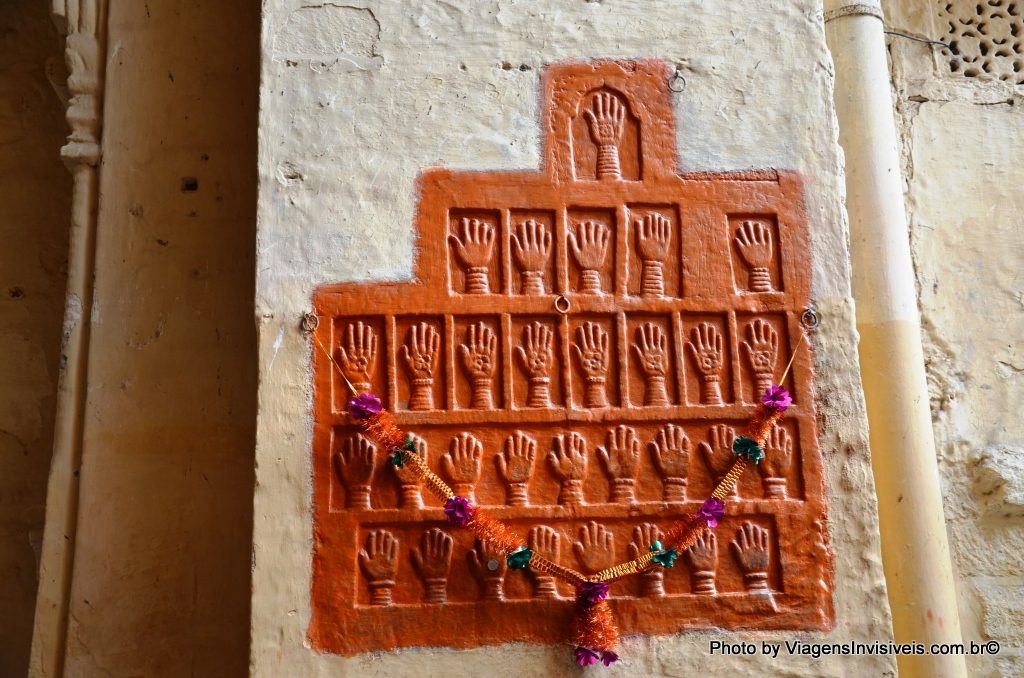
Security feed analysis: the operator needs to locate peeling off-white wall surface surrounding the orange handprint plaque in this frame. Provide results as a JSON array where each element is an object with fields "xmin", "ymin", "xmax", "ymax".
[{"xmin": 251, "ymin": 0, "xmax": 894, "ymax": 676}]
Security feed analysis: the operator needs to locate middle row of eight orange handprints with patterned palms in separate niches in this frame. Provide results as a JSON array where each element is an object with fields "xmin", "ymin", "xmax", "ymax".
[{"xmin": 338, "ymin": 319, "xmax": 779, "ymax": 411}]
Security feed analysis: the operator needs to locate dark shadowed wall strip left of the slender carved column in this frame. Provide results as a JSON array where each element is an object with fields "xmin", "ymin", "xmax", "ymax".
[{"xmin": 0, "ymin": 0, "xmax": 71, "ymax": 676}]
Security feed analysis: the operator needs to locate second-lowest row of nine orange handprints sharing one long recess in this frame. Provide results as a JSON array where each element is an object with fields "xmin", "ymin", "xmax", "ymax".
[{"xmin": 334, "ymin": 424, "xmax": 794, "ymax": 509}]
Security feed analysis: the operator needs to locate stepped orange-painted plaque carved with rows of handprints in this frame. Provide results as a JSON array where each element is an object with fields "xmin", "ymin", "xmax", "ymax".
[{"xmin": 309, "ymin": 61, "xmax": 834, "ymax": 654}]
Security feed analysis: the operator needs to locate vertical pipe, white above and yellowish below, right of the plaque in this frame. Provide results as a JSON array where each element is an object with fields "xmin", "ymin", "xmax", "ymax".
[{"xmin": 824, "ymin": 0, "xmax": 967, "ymax": 677}]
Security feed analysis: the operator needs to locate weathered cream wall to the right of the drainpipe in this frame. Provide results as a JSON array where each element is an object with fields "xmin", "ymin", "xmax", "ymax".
[{"xmin": 887, "ymin": 0, "xmax": 1024, "ymax": 676}]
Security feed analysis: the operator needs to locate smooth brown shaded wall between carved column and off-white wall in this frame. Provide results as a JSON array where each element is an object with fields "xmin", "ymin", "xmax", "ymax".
[{"xmin": 52, "ymin": 0, "xmax": 259, "ymax": 677}]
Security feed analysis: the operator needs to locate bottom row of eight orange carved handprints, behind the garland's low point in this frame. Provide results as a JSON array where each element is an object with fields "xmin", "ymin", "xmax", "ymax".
[{"xmin": 358, "ymin": 521, "xmax": 771, "ymax": 605}]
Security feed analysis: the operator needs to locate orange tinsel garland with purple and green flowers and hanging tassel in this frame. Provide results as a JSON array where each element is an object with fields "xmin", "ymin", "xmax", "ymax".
[{"xmin": 348, "ymin": 386, "xmax": 793, "ymax": 667}]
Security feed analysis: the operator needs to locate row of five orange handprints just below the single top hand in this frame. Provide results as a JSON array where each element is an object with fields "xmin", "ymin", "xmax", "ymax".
[{"xmin": 449, "ymin": 212, "xmax": 774, "ymax": 297}]
